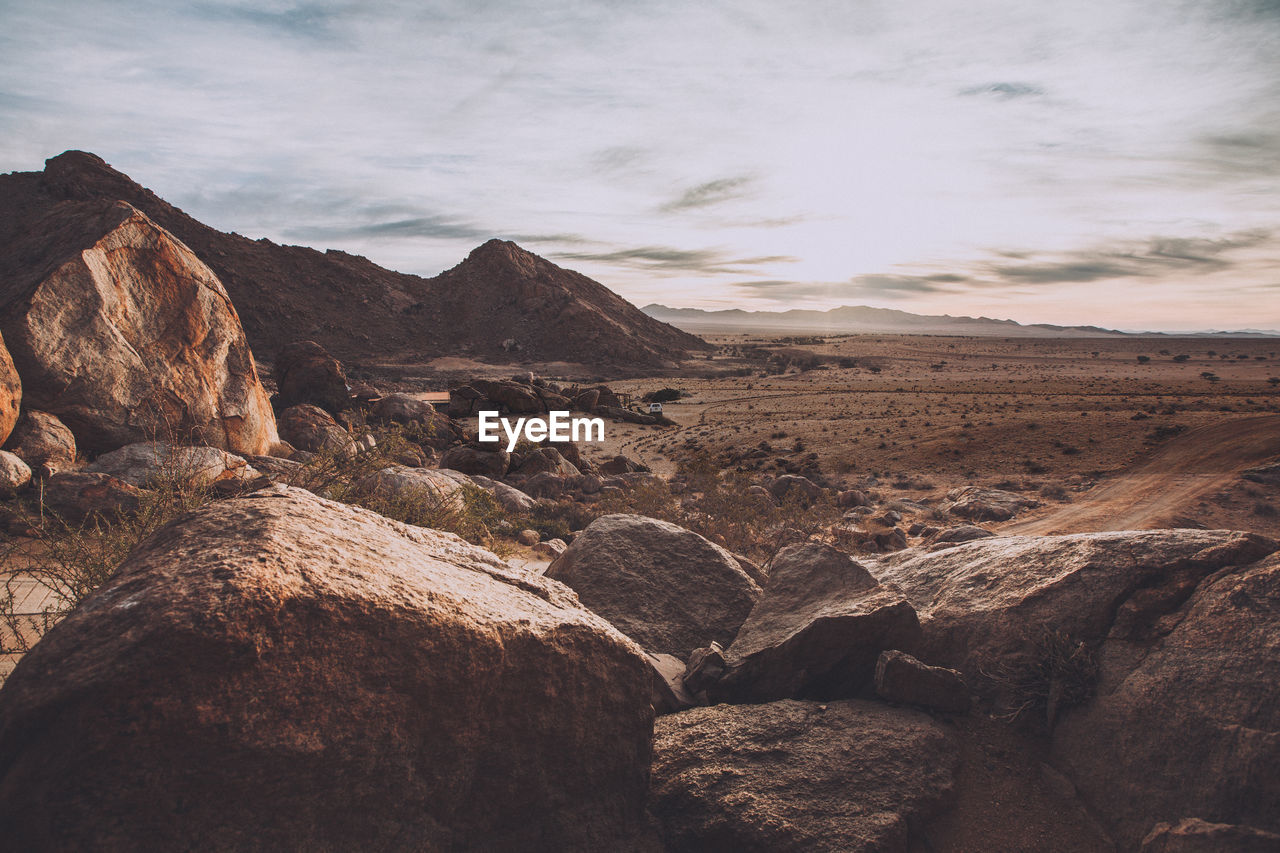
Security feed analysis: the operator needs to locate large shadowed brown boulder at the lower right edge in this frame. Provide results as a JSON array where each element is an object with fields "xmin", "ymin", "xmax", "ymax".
[{"xmin": 1052, "ymin": 555, "xmax": 1280, "ymax": 849}]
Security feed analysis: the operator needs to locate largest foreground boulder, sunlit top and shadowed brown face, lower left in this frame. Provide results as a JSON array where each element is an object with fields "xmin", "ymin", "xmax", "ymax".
[{"xmin": 0, "ymin": 487, "xmax": 653, "ymax": 852}]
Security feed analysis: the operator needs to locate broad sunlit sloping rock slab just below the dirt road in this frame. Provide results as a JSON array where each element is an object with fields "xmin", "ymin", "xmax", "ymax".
[{"xmin": 868, "ymin": 530, "xmax": 1280, "ymax": 676}]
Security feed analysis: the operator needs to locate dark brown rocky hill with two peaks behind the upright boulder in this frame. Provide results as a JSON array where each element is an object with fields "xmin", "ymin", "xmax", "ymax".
[{"xmin": 0, "ymin": 151, "xmax": 707, "ymax": 368}]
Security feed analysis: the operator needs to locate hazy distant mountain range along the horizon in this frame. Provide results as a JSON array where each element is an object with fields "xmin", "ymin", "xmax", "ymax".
[{"xmin": 640, "ymin": 302, "xmax": 1280, "ymax": 338}]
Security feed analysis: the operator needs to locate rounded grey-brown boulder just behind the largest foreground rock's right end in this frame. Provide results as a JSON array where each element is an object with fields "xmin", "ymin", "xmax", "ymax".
[{"xmin": 547, "ymin": 514, "xmax": 760, "ymax": 658}]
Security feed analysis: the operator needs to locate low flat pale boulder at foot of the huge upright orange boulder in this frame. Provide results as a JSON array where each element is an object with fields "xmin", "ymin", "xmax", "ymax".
[{"xmin": 84, "ymin": 442, "xmax": 257, "ymax": 488}]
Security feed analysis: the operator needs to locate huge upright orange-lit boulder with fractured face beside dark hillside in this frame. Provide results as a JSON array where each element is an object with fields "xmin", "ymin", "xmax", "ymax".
[{"xmin": 0, "ymin": 201, "xmax": 276, "ymax": 455}]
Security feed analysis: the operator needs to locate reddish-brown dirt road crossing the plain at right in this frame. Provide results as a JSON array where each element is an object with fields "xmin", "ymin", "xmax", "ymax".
[{"xmin": 1000, "ymin": 415, "xmax": 1280, "ymax": 534}]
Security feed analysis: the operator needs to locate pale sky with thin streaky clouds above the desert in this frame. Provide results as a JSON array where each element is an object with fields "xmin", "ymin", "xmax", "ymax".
[{"xmin": 0, "ymin": 0, "xmax": 1280, "ymax": 330}]
